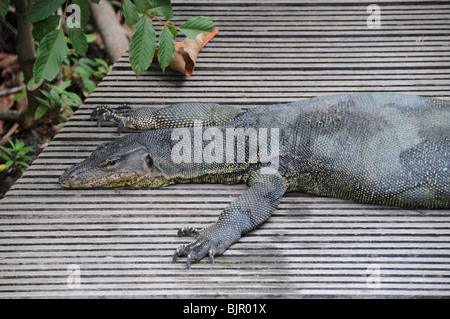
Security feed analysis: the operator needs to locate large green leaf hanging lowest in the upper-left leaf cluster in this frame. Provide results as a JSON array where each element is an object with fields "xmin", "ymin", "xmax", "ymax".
[{"xmin": 33, "ymin": 29, "xmax": 68, "ymax": 82}]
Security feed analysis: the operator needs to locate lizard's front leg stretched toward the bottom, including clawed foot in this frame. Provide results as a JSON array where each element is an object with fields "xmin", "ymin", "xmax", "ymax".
[{"xmin": 173, "ymin": 171, "xmax": 286, "ymax": 269}]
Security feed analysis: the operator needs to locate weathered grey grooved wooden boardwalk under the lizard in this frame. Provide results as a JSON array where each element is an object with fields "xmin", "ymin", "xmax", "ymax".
[{"xmin": 0, "ymin": 0, "xmax": 450, "ymax": 298}]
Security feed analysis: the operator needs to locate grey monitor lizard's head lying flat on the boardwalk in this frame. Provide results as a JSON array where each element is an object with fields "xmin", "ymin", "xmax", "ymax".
[{"xmin": 59, "ymin": 131, "xmax": 173, "ymax": 188}]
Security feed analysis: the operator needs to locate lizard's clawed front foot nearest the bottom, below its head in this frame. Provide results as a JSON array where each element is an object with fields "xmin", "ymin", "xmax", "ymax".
[{"xmin": 172, "ymin": 226, "xmax": 240, "ymax": 269}]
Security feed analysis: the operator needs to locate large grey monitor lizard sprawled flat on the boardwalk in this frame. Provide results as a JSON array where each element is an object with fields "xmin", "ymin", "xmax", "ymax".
[{"xmin": 60, "ymin": 93, "xmax": 450, "ymax": 267}]
